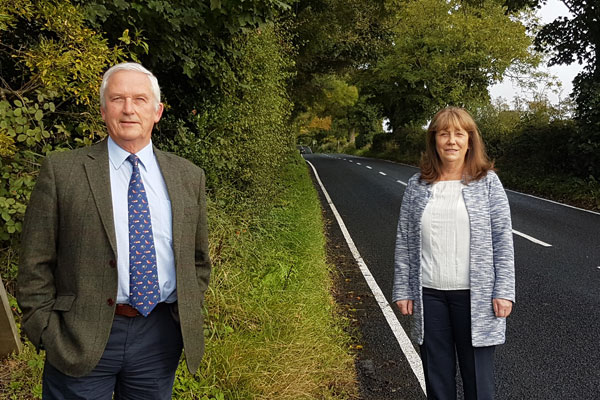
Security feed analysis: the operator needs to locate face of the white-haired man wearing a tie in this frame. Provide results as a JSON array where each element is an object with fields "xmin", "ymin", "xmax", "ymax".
[{"xmin": 100, "ymin": 71, "xmax": 163, "ymax": 153}]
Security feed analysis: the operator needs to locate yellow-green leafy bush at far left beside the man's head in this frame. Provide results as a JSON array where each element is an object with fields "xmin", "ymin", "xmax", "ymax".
[{"xmin": 0, "ymin": 0, "xmax": 125, "ymax": 290}]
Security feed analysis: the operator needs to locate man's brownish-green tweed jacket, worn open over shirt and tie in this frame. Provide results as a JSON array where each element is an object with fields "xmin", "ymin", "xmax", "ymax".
[{"xmin": 17, "ymin": 141, "xmax": 210, "ymax": 376}]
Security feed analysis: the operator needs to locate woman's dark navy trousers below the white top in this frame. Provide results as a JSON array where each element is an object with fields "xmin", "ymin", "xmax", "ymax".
[{"xmin": 421, "ymin": 288, "xmax": 495, "ymax": 400}]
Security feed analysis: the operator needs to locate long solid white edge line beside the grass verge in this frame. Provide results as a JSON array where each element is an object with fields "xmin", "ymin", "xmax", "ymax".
[{"xmin": 306, "ymin": 161, "xmax": 426, "ymax": 394}]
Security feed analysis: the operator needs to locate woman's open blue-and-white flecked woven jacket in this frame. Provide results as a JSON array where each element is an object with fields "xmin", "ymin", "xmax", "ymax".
[{"xmin": 392, "ymin": 171, "xmax": 515, "ymax": 347}]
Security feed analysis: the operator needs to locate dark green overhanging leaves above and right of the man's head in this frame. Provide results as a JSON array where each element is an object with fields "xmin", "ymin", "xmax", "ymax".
[{"xmin": 75, "ymin": 0, "xmax": 291, "ymax": 120}]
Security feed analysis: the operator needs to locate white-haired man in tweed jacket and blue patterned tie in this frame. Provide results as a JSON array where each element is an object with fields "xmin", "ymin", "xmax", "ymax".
[{"xmin": 18, "ymin": 63, "xmax": 210, "ymax": 400}]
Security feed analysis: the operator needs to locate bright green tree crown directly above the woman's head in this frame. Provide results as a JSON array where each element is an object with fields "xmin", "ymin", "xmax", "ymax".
[{"xmin": 360, "ymin": 0, "xmax": 537, "ymax": 129}]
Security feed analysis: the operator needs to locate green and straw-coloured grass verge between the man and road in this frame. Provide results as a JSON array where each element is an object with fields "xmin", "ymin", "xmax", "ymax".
[{"xmin": 0, "ymin": 155, "xmax": 357, "ymax": 400}]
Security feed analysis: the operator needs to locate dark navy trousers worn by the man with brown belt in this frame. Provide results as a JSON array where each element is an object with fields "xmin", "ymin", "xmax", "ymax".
[{"xmin": 42, "ymin": 303, "xmax": 183, "ymax": 400}]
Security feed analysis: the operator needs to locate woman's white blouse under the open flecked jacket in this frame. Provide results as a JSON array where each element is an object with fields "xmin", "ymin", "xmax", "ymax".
[{"xmin": 421, "ymin": 181, "xmax": 471, "ymax": 290}]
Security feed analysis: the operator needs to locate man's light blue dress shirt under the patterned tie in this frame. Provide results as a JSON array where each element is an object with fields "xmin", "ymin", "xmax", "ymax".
[{"xmin": 108, "ymin": 137, "xmax": 177, "ymax": 304}]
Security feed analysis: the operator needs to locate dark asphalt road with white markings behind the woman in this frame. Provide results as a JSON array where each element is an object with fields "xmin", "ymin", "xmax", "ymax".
[{"xmin": 305, "ymin": 154, "xmax": 600, "ymax": 400}]
